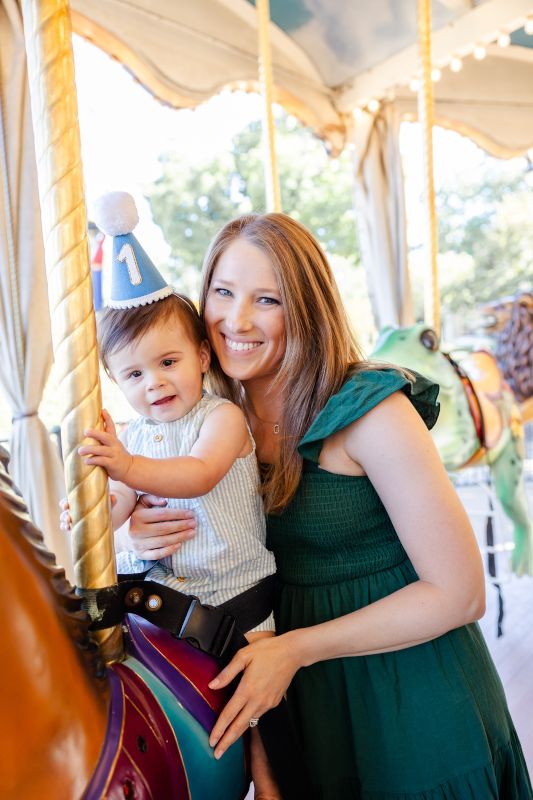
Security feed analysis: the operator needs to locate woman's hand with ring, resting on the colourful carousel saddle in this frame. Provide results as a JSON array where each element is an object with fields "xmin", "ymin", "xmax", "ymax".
[{"xmin": 209, "ymin": 631, "xmax": 302, "ymax": 758}]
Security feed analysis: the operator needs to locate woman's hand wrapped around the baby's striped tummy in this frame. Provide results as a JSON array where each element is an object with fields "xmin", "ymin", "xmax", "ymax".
[{"xmin": 125, "ymin": 494, "xmax": 196, "ymax": 561}]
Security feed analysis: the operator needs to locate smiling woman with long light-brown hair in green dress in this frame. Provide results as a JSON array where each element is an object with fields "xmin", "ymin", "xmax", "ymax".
[{"xmin": 127, "ymin": 214, "xmax": 533, "ymax": 800}]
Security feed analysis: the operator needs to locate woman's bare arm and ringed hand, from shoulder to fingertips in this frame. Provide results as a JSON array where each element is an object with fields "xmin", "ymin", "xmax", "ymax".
[{"xmin": 210, "ymin": 393, "xmax": 485, "ymax": 754}]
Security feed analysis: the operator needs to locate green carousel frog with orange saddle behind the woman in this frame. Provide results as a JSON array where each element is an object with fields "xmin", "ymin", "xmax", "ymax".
[{"xmin": 372, "ymin": 323, "xmax": 533, "ymax": 575}]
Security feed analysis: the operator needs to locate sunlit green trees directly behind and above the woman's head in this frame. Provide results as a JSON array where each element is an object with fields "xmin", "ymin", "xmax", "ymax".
[{"xmin": 148, "ymin": 109, "xmax": 359, "ymax": 291}]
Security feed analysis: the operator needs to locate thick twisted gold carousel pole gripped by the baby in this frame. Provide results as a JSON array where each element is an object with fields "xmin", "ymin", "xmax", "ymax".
[{"xmin": 21, "ymin": 0, "xmax": 122, "ymax": 662}]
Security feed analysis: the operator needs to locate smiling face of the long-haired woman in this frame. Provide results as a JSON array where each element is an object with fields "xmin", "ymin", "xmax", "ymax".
[{"xmin": 205, "ymin": 238, "xmax": 285, "ymax": 383}]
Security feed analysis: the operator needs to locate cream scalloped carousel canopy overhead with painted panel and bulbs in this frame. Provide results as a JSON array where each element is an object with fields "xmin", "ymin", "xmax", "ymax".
[{"xmin": 71, "ymin": 0, "xmax": 533, "ymax": 156}]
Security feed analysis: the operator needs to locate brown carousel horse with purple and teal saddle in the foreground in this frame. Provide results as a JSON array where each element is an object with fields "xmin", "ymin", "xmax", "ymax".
[{"xmin": 0, "ymin": 451, "xmax": 249, "ymax": 800}]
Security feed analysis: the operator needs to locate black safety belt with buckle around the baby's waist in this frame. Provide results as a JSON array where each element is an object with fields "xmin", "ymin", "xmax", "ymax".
[{"xmin": 83, "ymin": 572, "xmax": 311, "ymax": 800}]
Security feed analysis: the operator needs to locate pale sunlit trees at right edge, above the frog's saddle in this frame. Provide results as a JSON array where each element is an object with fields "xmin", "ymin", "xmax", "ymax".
[{"xmin": 437, "ymin": 160, "xmax": 533, "ymax": 311}]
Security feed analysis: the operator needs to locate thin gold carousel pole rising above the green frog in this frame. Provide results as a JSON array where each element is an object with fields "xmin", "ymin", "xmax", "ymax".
[{"xmin": 418, "ymin": 0, "xmax": 440, "ymax": 335}]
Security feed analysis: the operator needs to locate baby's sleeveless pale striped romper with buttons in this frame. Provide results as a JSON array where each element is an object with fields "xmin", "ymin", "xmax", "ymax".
[{"xmin": 117, "ymin": 393, "xmax": 276, "ymax": 631}]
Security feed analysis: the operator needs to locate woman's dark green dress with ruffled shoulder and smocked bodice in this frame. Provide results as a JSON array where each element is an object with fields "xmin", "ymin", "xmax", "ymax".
[{"xmin": 267, "ymin": 370, "xmax": 533, "ymax": 800}]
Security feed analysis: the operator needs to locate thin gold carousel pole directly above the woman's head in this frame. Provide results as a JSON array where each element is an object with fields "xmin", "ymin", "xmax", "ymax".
[{"xmin": 256, "ymin": 0, "xmax": 281, "ymax": 211}]
